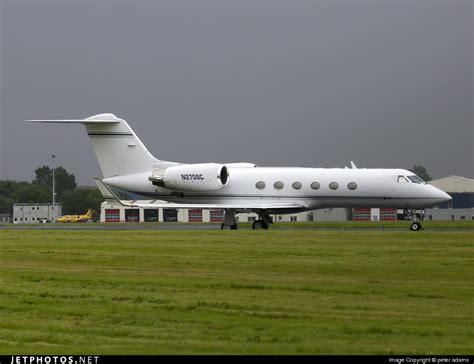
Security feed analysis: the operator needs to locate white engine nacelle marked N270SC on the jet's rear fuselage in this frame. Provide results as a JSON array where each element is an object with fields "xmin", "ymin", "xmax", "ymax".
[{"xmin": 149, "ymin": 163, "xmax": 229, "ymax": 192}]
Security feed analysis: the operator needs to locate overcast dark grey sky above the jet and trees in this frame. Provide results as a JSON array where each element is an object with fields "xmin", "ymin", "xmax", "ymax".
[{"xmin": 0, "ymin": 0, "xmax": 474, "ymax": 185}]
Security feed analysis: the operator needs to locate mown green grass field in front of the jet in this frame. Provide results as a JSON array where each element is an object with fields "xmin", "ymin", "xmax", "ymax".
[{"xmin": 0, "ymin": 229, "xmax": 474, "ymax": 354}]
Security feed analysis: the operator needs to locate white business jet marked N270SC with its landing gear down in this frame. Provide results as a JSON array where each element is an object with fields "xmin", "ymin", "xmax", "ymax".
[{"xmin": 29, "ymin": 114, "xmax": 451, "ymax": 231}]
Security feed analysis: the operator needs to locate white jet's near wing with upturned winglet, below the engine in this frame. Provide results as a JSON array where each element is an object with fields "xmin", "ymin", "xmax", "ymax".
[{"xmin": 94, "ymin": 178, "xmax": 307, "ymax": 211}]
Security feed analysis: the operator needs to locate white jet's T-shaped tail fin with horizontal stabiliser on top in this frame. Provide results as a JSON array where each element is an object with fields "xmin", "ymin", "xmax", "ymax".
[{"xmin": 28, "ymin": 114, "xmax": 161, "ymax": 177}]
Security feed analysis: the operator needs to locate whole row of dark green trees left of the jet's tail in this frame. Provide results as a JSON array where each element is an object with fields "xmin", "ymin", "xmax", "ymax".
[{"xmin": 0, "ymin": 166, "xmax": 104, "ymax": 215}]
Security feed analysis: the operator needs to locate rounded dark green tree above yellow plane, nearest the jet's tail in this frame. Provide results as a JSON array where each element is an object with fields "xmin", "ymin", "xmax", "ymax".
[{"xmin": 61, "ymin": 188, "xmax": 104, "ymax": 215}]
